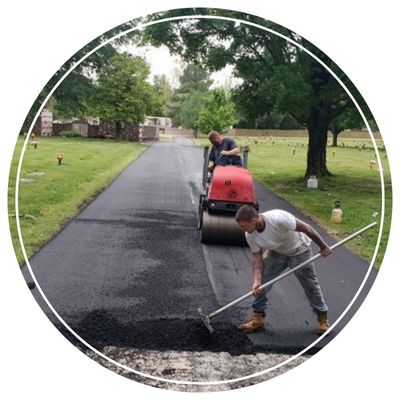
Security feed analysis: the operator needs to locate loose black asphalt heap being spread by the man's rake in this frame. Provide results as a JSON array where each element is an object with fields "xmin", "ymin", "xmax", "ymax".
[{"xmin": 59, "ymin": 311, "xmax": 256, "ymax": 355}]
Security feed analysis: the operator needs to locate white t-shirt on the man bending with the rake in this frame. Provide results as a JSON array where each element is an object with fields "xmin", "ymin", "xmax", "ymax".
[{"xmin": 245, "ymin": 210, "xmax": 311, "ymax": 256}]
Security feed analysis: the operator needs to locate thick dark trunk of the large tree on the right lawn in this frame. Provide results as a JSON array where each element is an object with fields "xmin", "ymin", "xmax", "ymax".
[{"xmin": 304, "ymin": 107, "xmax": 331, "ymax": 179}]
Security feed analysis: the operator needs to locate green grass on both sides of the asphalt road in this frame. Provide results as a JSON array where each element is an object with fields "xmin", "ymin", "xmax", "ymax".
[{"xmin": 9, "ymin": 137, "xmax": 392, "ymax": 265}]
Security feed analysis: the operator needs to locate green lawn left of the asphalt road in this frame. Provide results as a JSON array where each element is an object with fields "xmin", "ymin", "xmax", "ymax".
[{"xmin": 8, "ymin": 137, "xmax": 146, "ymax": 263}]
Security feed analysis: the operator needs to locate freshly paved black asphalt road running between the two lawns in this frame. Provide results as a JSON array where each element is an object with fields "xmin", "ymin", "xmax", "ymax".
[{"xmin": 23, "ymin": 138, "xmax": 376, "ymax": 382}]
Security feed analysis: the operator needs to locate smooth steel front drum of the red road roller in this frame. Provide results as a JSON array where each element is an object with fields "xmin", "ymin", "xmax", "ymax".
[{"xmin": 201, "ymin": 210, "xmax": 246, "ymax": 246}]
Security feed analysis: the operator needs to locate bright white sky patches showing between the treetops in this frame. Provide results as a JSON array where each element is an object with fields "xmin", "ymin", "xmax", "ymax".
[{"xmin": 123, "ymin": 46, "xmax": 240, "ymax": 88}]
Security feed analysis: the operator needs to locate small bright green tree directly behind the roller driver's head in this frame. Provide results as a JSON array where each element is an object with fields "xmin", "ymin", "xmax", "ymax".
[{"xmin": 196, "ymin": 88, "xmax": 238, "ymax": 133}]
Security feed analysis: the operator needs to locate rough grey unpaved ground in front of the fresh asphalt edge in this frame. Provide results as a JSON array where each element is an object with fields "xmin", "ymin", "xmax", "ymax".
[{"xmin": 85, "ymin": 347, "xmax": 309, "ymax": 392}]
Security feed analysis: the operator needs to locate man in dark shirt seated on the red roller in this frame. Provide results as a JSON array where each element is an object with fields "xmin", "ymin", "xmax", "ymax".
[{"xmin": 208, "ymin": 131, "xmax": 243, "ymax": 172}]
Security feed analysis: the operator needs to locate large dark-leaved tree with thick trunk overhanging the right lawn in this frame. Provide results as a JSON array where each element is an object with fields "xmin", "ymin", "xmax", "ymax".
[{"xmin": 145, "ymin": 9, "xmax": 376, "ymax": 177}]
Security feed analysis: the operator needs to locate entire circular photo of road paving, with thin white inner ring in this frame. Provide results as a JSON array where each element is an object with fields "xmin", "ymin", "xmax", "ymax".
[{"xmin": 9, "ymin": 8, "xmax": 391, "ymax": 392}]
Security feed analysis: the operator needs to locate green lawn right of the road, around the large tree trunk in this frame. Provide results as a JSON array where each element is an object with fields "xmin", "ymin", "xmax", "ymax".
[{"xmin": 196, "ymin": 138, "xmax": 392, "ymax": 265}]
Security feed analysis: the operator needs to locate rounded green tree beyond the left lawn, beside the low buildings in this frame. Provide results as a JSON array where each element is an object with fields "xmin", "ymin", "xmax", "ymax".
[{"xmin": 92, "ymin": 54, "xmax": 151, "ymax": 133}]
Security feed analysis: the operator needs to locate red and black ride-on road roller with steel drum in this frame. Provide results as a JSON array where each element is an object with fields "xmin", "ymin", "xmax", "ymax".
[{"xmin": 198, "ymin": 146, "xmax": 258, "ymax": 246}]
